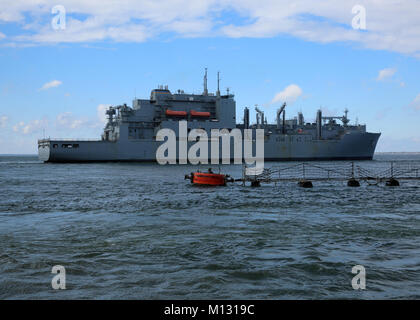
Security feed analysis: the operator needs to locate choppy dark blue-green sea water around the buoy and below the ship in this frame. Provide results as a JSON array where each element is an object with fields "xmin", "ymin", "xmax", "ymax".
[{"xmin": 0, "ymin": 154, "xmax": 420, "ymax": 299}]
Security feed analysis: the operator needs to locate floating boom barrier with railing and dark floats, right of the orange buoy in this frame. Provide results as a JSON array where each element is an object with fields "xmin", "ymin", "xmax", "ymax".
[{"xmin": 240, "ymin": 161, "xmax": 420, "ymax": 188}]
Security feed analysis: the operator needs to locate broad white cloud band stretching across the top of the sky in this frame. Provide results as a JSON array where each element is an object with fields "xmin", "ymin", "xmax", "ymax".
[{"xmin": 0, "ymin": 0, "xmax": 420, "ymax": 58}]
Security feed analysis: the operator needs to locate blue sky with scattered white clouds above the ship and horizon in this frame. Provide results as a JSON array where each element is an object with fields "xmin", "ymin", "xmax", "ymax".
[{"xmin": 0, "ymin": 0, "xmax": 420, "ymax": 153}]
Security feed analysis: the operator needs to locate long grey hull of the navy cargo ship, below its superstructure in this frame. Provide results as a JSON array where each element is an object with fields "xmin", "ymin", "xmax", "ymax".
[{"xmin": 38, "ymin": 132, "xmax": 380, "ymax": 163}]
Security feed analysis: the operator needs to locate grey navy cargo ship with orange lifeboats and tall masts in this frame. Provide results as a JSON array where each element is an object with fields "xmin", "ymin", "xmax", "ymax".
[{"xmin": 38, "ymin": 70, "xmax": 380, "ymax": 162}]
